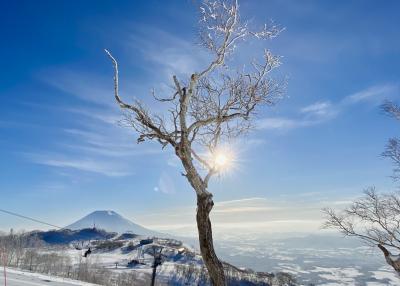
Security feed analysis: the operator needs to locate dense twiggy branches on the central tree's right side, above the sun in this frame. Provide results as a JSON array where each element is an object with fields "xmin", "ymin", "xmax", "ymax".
[{"xmin": 188, "ymin": 50, "xmax": 283, "ymax": 149}]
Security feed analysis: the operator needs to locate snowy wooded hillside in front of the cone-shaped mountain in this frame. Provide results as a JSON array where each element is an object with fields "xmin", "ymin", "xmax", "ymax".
[{"xmin": 8, "ymin": 228, "xmax": 272, "ymax": 286}]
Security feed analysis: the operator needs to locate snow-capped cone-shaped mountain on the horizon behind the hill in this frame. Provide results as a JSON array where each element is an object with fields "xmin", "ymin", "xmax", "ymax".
[{"xmin": 65, "ymin": 210, "xmax": 160, "ymax": 236}]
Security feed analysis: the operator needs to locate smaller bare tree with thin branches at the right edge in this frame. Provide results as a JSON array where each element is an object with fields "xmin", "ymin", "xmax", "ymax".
[{"xmin": 324, "ymin": 101, "xmax": 400, "ymax": 274}]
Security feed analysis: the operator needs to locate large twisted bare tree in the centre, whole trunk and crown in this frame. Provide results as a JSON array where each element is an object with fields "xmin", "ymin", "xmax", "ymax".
[{"xmin": 106, "ymin": 0, "xmax": 283, "ymax": 285}]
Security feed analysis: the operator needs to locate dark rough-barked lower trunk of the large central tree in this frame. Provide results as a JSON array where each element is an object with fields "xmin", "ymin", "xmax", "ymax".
[{"xmin": 196, "ymin": 193, "xmax": 226, "ymax": 286}]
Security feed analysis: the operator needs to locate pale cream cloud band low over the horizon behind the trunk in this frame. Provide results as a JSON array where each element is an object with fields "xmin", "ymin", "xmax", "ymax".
[{"xmin": 135, "ymin": 193, "xmax": 351, "ymax": 237}]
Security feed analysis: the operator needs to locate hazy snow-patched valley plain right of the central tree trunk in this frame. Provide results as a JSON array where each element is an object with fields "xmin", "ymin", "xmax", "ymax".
[{"xmin": 217, "ymin": 236, "xmax": 400, "ymax": 286}]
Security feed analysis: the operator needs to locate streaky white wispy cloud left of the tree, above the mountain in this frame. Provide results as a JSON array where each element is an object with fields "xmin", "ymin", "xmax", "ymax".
[{"xmin": 19, "ymin": 105, "xmax": 161, "ymax": 177}]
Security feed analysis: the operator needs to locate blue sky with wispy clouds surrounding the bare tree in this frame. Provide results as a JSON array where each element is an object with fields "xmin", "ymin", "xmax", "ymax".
[{"xmin": 0, "ymin": 0, "xmax": 400, "ymax": 233}]
